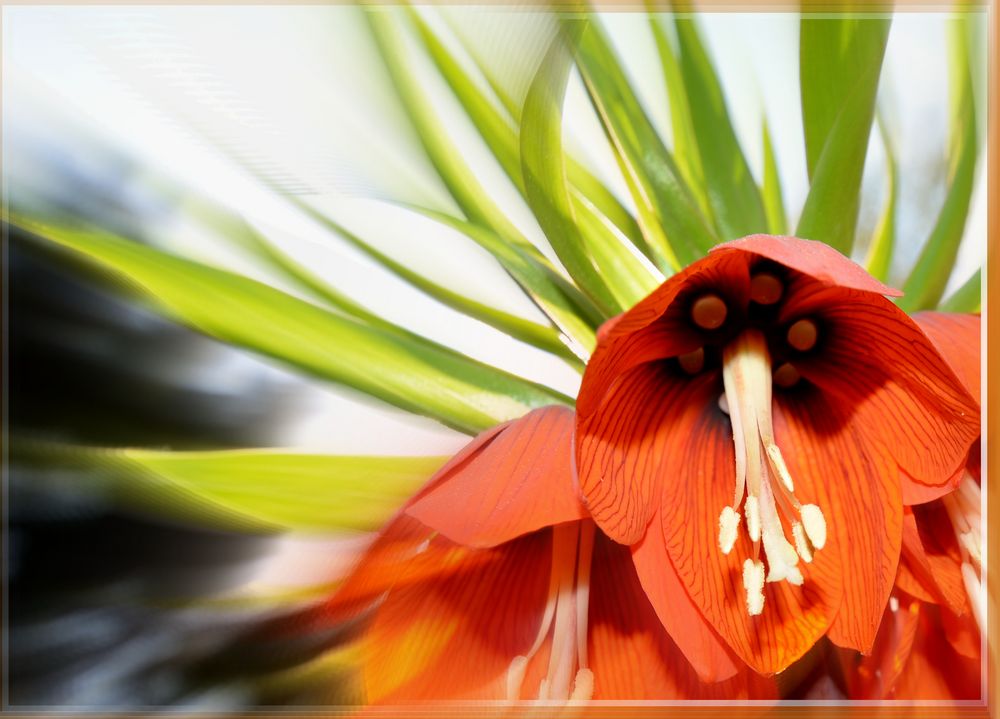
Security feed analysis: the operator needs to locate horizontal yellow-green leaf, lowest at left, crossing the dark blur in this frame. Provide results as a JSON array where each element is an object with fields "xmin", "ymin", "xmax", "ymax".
[{"xmin": 15, "ymin": 445, "xmax": 447, "ymax": 532}]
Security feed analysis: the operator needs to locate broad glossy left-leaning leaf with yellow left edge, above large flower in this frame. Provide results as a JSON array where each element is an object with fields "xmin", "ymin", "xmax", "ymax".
[{"xmin": 577, "ymin": 22, "xmax": 718, "ymax": 272}]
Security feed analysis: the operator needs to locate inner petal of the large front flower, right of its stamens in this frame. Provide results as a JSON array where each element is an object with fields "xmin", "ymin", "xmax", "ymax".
[{"xmin": 775, "ymin": 386, "xmax": 903, "ymax": 652}]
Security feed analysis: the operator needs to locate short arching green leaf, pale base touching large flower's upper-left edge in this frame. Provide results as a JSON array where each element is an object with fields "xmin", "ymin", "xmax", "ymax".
[{"xmin": 410, "ymin": 207, "xmax": 603, "ymax": 359}]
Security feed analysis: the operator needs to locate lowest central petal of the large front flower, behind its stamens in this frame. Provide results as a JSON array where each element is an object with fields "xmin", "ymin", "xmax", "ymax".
[{"xmin": 661, "ymin": 378, "xmax": 844, "ymax": 674}]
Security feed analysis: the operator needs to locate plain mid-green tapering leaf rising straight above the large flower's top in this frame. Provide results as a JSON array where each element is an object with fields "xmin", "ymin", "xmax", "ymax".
[{"xmin": 674, "ymin": 15, "xmax": 767, "ymax": 240}]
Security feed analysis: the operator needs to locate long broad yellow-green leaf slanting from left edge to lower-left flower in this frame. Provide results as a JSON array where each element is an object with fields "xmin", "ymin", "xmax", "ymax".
[{"xmin": 16, "ymin": 220, "xmax": 572, "ymax": 434}]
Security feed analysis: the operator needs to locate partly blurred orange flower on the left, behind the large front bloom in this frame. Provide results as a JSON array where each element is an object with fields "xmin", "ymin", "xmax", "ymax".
[{"xmin": 323, "ymin": 407, "xmax": 775, "ymax": 703}]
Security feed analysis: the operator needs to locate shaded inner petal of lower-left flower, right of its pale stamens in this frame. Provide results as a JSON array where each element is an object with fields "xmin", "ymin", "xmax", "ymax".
[{"xmin": 589, "ymin": 535, "xmax": 776, "ymax": 700}]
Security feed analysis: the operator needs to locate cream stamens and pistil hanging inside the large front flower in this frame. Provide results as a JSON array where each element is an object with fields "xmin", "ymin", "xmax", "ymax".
[{"xmin": 719, "ymin": 326, "xmax": 826, "ymax": 616}]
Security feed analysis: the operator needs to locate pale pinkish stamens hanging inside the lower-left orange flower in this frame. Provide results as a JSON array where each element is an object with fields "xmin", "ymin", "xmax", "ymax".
[{"xmin": 507, "ymin": 522, "xmax": 596, "ymax": 701}]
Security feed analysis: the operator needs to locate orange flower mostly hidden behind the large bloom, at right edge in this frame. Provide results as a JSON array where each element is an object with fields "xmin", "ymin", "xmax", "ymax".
[{"xmin": 839, "ymin": 312, "xmax": 985, "ymax": 700}]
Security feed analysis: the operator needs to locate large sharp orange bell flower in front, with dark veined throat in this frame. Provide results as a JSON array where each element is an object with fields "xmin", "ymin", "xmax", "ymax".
[{"xmin": 576, "ymin": 235, "xmax": 979, "ymax": 679}]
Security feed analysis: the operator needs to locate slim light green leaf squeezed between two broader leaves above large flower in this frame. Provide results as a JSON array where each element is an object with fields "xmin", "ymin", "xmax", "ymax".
[{"xmin": 649, "ymin": 14, "xmax": 715, "ymax": 224}]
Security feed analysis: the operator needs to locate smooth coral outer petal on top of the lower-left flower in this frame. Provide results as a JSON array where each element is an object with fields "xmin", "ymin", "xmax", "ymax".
[{"xmin": 405, "ymin": 407, "xmax": 587, "ymax": 547}]
